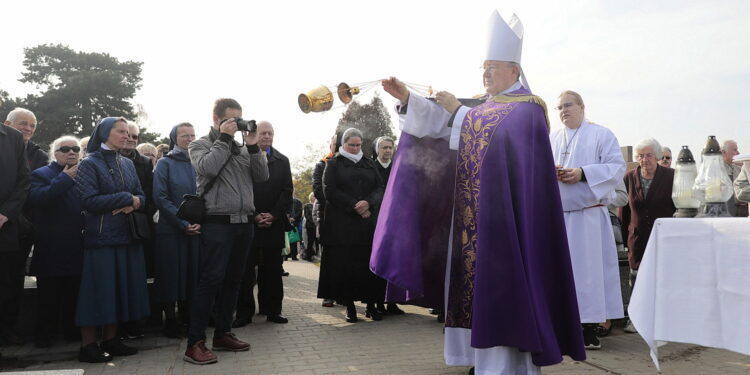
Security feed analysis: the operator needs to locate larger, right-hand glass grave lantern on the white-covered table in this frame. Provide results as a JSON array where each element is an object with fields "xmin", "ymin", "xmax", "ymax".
[{"xmin": 693, "ymin": 135, "xmax": 733, "ymax": 217}]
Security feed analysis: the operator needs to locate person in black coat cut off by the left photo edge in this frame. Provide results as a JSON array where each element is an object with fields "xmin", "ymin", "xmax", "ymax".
[{"xmin": 0, "ymin": 125, "xmax": 29, "ymax": 350}]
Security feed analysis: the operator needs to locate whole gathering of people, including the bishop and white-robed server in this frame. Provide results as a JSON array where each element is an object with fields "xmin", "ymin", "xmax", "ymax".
[{"xmin": 0, "ymin": 15, "xmax": 750, "ymax": 374}]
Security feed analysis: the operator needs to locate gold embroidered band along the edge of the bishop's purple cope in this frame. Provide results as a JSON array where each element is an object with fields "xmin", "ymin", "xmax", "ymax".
[{"xmin": 446, "ymin": 94, "xmax": 549, "ymax": 328}]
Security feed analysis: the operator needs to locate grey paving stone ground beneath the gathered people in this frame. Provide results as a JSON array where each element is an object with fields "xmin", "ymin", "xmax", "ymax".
[{"xmin": 0, "ymin": 261, "xmax": 750, "ymax": 375}]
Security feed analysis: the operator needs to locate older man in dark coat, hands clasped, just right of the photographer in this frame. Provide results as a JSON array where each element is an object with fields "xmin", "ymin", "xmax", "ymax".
[{"xmin": 233, "ymin": 121, "xmax": 294, "ymax": 327}]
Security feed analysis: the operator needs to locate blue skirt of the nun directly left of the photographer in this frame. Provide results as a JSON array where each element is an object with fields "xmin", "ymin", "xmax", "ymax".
[{"xmin": 154, "ymin": 234, "xmax": 201, "ymax": 304}]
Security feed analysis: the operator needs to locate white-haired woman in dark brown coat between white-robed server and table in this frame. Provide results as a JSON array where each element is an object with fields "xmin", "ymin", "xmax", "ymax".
[{"xmin": 620, "ymin": 138, "xmax": 676, "ymax": 332}]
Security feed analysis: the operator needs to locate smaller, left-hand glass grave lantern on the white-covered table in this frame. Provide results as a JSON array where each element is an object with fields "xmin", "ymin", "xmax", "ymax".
[{"xmin": 672, "ymin": 146, "xmax": 701, "ymax": 217}]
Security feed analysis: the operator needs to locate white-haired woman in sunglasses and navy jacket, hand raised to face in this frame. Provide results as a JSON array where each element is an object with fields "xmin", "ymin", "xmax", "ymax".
[{"xmin": 27, "ymin": 136, "xmax": 84, "ymax": 347}]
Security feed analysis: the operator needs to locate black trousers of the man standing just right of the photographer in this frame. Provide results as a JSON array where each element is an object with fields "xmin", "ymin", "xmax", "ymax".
[{"xmin": 237, "ymin": 248, "xmax": 284, "ymax": 319}]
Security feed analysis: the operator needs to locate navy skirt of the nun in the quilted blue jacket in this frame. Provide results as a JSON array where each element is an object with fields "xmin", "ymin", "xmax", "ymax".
[{"xmin": 76, "ymin": 245, "xmax": 149, "ymax": 327}]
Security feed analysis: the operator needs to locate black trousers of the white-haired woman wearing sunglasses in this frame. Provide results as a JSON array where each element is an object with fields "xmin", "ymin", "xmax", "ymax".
[{"xmin": 36, "ymin": 275, "xmax": 81, "ymax": 339}]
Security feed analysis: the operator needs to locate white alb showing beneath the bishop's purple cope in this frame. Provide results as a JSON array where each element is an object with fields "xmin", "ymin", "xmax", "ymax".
[{"xmin": 399, "ymin": 82, "xmax": 540, "ymax": 375}]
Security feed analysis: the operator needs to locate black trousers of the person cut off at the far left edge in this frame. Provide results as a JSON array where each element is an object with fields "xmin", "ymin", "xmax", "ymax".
[{"xmin": 0, "ymin": 241, "xmax": 31, "ymax": 330}]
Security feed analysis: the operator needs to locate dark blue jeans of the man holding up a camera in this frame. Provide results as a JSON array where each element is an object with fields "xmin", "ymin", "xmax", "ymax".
[{"xmin": 188, "ymin": 223, "xmax": 255, "ymax": 346}]
